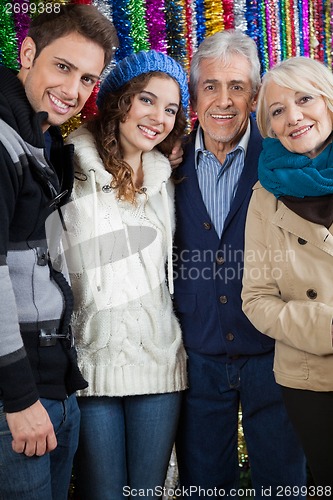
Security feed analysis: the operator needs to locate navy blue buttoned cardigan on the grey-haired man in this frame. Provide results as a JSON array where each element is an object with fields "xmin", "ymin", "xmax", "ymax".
[{"xmin": 174, "ymin": 118, "xmax": 274, "ymax": 357}]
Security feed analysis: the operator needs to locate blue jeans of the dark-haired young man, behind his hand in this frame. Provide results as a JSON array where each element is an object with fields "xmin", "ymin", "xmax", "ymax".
[{"xmin": 0, "ymin": 395, "xmax": 80, "ymax": 500}]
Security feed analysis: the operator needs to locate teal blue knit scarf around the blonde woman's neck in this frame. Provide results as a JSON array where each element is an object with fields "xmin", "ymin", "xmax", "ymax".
[{"xmin": 258, "ymin": 138, "xmax": 333, "ymax": 198}]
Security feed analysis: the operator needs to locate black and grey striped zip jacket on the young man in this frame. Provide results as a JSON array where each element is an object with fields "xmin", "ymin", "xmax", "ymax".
[{"xmin": 0, "ymin": 67, "xmax": 87, "ymax": 412}]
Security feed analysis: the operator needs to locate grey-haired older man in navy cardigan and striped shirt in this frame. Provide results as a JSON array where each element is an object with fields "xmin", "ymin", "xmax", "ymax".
[{"xmin": 174, "ymin": 30, "xmax": 306, "ymax": 498}]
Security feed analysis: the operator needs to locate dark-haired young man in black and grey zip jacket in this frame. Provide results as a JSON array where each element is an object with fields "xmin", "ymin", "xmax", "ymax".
[{"xmin": 0, "ymin": 5, "xmax": 117, "ymax": 500}]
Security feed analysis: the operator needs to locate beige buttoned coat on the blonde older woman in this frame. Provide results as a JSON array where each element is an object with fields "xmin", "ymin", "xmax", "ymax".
[{"xmin": 242, "ymin": 183, "xmax": 333, "ymax": 391}]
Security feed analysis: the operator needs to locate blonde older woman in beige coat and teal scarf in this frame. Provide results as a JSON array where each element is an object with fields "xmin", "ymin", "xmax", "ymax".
[{"xmin": 243, "ymin": 57, "xmax": 333, "ymax": 496}]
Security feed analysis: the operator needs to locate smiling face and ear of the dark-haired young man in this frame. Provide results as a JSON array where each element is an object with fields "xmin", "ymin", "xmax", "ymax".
[{"xmin": 18, "ymin": 32, "xmax": 104, "ymax": 131}]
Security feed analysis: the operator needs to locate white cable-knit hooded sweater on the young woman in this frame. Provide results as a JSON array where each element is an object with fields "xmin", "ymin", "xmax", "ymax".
[{"xmin": 65, "ymin": 127, "xmax": 186, "ymax": 396}]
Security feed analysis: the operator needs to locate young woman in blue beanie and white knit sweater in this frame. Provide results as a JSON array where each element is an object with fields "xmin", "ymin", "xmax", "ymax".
[{"xmin": 66, "ymin": 50, "xmax": 188, "ymax": 500}]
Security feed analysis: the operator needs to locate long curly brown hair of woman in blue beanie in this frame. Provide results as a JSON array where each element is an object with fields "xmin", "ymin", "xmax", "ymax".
[{"xmin": 87, "ymin": 72, "xmax": 187, "ymax": 203}]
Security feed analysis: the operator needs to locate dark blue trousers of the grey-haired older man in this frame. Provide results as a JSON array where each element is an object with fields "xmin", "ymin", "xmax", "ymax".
[{"xmin": 176, "ymin": 352, "xmax": 306, "ymax": 500}]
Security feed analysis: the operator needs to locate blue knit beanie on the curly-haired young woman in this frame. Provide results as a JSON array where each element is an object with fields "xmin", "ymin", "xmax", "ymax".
[{"xmin": 96, "ymin": 50, "xmax": 189, "ymax": 113}]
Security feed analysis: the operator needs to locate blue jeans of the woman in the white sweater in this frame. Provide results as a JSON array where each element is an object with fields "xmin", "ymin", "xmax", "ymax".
[{"xmin": 74, "ymin": 393, "xmax": 181, "ymax": 500}]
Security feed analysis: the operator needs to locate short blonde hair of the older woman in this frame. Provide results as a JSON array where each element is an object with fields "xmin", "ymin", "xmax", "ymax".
[{"xmin": 256, "ymin": 56, "xmax": 333, "ymax": 137}]
